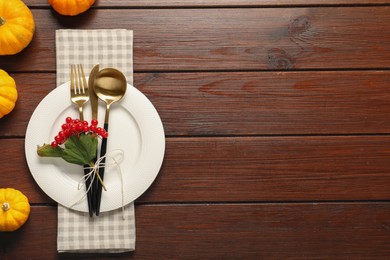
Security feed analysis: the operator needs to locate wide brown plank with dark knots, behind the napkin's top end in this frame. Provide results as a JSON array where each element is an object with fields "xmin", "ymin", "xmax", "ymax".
[{"xmin": 0, "ymin": 7, "xmax": 390, "ymax": 71}]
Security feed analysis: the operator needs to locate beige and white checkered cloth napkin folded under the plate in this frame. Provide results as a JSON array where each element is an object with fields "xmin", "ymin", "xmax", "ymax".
[{"xmin": 56, "ymin": 29, "xmax": 135, "ymax": 253}]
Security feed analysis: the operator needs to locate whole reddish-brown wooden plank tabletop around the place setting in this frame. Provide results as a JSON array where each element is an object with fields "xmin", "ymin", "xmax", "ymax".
[{"xmin": 0, "ymin": 0, "xmax": 390, "ymax": 259}]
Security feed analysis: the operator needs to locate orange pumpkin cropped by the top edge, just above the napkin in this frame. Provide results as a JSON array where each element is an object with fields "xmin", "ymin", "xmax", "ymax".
[{"xmin": 48, "ymin": 0, "xmax": 95, "ymax": 16}]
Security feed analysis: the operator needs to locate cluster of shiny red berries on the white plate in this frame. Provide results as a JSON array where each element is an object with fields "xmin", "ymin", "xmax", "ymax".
[{"xmin": 51, "ymin": 117, "xmax": 108, "ymax": 147}]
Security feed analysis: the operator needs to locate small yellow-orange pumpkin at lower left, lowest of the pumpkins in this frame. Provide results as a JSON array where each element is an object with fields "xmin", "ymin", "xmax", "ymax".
[{"xmin": 0, "ymin": 188, "xmax": 30, "ymax": 232}]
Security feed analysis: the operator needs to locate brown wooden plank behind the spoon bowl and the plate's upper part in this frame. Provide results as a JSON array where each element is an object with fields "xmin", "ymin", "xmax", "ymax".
[{"xmin": 0, "ymin": 71, "xmax": 390, "ymax": 136}]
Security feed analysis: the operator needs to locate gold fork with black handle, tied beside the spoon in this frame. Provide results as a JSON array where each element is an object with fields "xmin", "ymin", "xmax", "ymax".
[{"xmin": 70, "ymin": 64, "xmax": 94, "ymax": 217}]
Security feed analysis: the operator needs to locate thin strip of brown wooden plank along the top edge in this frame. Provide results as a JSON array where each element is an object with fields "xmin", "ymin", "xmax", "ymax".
[{"xmin": 24, "ymin": 0, "xmax": 390, "ymax": 7}]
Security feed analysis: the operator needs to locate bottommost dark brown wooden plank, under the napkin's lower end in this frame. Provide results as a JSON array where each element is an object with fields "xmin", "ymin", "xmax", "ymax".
[{"xmin": 0, "ymin": 203, "xmax": 390, "ymax": 260}]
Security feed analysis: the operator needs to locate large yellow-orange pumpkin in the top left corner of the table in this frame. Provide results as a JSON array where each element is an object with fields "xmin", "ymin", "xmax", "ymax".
[{"xmin": 0, "ymin": 0, "xmax": 35, "ymax": 55}]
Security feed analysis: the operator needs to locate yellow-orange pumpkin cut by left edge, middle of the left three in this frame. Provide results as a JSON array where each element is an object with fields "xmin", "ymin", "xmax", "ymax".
[{"xmin": 0, "ymin": 69, "xmax": 18, "ymax": 118}]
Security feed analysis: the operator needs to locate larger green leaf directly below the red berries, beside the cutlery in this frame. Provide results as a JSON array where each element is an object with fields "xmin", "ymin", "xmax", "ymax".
[{"xmin": 62, "ymin": 134, "xmax": 98, "ymax": 165}]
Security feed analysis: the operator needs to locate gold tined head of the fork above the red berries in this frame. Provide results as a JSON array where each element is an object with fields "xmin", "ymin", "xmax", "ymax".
[{"xmin": 70, "ymin": 64, "xmax": 89, "ymax": 121}]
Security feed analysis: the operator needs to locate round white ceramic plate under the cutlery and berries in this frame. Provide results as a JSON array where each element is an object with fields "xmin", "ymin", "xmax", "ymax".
[{"xmin": 25, "ymin": 82, "xmax": 165, "ymax": 212}]
